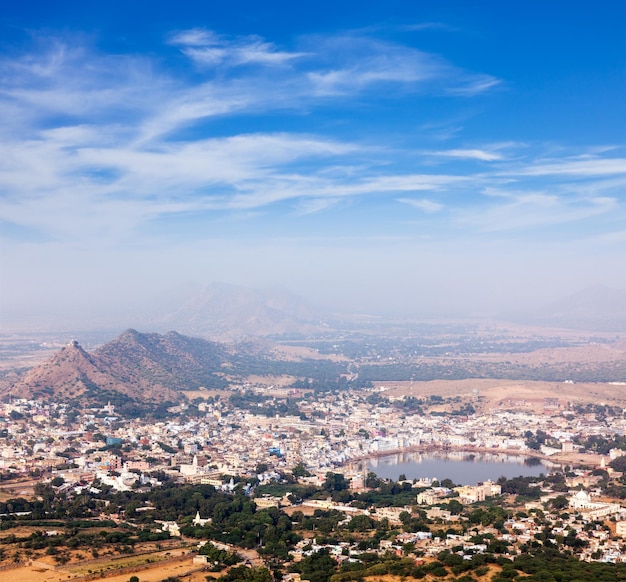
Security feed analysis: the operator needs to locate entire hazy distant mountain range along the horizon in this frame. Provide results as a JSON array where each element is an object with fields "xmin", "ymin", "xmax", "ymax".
[{"xmin": 6, "ymin": 283, "xmax": 626, "ymax": 345}]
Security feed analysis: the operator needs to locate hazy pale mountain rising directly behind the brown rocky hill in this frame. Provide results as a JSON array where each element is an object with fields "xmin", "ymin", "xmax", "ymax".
[{"xmin": 147, "ymin": 283, "xmax": 324, "ymax": 339}]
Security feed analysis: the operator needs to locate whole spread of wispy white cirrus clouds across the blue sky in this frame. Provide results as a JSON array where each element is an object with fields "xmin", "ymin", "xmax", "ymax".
[{"xmin": 0, "ymin": 29, "xmax": 625, "ymax": 253}]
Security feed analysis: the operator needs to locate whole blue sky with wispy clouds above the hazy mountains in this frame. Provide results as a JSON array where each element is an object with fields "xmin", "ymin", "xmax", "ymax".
[{"xmin": 0, "ymin": 0, "xmax": 626, "ymax": 320}]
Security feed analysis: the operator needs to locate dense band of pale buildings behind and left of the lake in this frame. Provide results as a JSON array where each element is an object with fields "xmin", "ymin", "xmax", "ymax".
[{"xmin": 0, "ymin": 391, "xmax": 626, "ymax": 488}]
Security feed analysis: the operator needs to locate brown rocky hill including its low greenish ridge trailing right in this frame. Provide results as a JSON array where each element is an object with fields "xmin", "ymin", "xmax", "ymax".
[{"xmin": 0, "ymin": 329, "xmax": 347, "ymax": 415}]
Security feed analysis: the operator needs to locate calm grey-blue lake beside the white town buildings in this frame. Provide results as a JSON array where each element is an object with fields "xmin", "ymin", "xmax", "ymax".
[{"xmin": 363, "ymin": 451, "xmax": 559, "ymax": 485}]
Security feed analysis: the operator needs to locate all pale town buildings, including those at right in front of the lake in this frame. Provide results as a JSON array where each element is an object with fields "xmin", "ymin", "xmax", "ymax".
[{"xmin": 0, "ymin": 390, "xmax": 626, "ymax": 561}]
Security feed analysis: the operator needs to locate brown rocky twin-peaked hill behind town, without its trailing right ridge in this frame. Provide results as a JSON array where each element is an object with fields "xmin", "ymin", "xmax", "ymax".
[{"xmin": 8, "ymin": 329, "xmax": 227, "ymax": 408}]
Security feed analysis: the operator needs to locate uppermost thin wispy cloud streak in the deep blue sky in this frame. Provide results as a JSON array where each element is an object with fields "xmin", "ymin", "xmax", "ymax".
[{"xmin": 169, "ymin": 29, "xmax": 499, "ymax": 96}]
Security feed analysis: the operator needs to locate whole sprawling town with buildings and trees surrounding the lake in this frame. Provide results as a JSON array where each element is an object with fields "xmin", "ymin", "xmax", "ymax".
[{"xmin": 0, "ymin": 385, "xmax": 626, "ymax": 580}]
